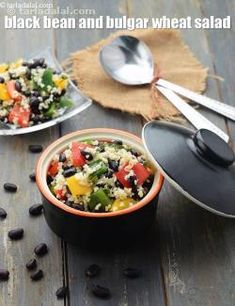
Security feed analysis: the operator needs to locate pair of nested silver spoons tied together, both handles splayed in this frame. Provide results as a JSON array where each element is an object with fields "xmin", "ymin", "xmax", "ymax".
[{"xmin": 99, "ymin": 35, "xmax": 231, "ymax": 142}]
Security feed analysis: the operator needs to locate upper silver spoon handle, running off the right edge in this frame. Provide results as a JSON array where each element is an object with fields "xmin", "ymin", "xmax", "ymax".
[{"xmin": 157, "ymin": 79, "xmax": 235, "ymax": 121}]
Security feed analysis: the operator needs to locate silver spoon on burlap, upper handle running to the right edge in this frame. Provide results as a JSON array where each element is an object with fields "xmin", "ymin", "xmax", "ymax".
[{"xmin": 100, "ymin": 35, "xmax": 235, "ymax": 120}]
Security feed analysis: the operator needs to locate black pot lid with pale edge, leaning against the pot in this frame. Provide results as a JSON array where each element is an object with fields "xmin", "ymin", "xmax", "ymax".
[{"xmin": 142, "ymin": 121, "xmax": 235, "ymax": 217}]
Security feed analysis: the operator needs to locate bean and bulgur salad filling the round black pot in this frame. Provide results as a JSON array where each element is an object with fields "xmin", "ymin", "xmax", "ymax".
[{"xmin": 47, "ymin": 139, "xmax": 154, "ymax": 212}]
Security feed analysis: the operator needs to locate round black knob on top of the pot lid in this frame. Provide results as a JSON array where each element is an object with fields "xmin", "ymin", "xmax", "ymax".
[{"xmin": 193, "ymin": 129, "xmax": 235, "ymax": 167}]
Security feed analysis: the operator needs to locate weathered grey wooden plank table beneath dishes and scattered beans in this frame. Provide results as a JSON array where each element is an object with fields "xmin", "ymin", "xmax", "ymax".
[{"xmin": 0, "ymin": 0, "xmax": 235, "ymax": 306}]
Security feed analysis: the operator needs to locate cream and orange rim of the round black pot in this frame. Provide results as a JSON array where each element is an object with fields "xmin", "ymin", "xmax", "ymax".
[{"xmin": 36, "ymin": 128, "xmax": 164, "ymax": 218}]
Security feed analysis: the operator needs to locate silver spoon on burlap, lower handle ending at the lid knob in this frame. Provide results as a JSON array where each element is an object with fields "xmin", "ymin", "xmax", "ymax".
[{"xmin": 100, "ymin": 35, "xmax": 229, "ymax": 142}]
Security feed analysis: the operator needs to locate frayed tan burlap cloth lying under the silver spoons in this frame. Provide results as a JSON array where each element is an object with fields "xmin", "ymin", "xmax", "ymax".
[{"xmin": 67, "ymin": 29, "xmax": 207, "ymax": 120}]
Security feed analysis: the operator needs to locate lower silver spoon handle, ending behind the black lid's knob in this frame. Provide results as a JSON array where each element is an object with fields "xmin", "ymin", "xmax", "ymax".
[{"xmin": 156, "ymin": 86, "xmax": 229, "ymax": 142}]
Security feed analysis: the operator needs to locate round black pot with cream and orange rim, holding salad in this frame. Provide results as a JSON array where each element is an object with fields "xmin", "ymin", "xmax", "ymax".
[{"xmin": 36, "ymin": 128, "xmax": 164, "ymax": 245}]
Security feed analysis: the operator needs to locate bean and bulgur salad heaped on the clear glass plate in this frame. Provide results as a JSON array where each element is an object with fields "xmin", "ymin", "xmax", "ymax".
[{"xmin": 0, "ymin": 58, "xmax": 73, "ymax": 128}]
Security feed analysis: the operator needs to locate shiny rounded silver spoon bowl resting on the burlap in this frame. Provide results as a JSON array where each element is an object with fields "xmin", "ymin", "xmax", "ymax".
[{"xmin": 99, "ymin": 35, "xmax": 154, "ymax": 85}]
